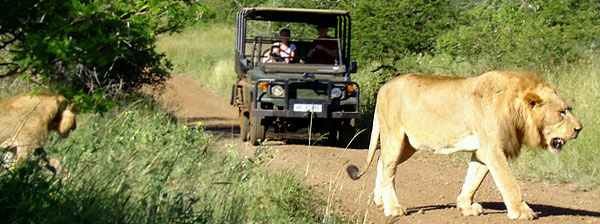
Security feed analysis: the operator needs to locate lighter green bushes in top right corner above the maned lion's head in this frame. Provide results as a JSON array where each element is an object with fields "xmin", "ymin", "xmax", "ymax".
[{"xmin": 436, "ymin": 0, "xmax": 600, "ymax": 69}]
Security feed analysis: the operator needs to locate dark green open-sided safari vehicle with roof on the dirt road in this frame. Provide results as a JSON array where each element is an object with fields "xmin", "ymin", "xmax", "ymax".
[{"xmin": 231, "ymin": 8, "xmax": 360, "ymax": 146}]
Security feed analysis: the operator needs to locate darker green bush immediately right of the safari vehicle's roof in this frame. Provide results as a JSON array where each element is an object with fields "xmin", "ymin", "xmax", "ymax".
[{"xmin": 349, "ymin": 0, "xmax": 458, "ymax": 60}]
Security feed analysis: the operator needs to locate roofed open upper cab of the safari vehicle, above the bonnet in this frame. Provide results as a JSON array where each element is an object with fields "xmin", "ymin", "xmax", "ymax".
[{"xmin": 236, "ymin": 7, "xmax": 354, "ymax": 76}]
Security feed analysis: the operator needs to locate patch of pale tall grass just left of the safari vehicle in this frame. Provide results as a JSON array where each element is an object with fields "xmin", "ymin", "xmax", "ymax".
[{"xmin": 157, "ymin": 24, "xmax": 236, "ymax": 98}]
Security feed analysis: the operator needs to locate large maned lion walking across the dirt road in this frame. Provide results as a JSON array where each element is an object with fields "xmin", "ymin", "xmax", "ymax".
[{"xmin": 348, "ymin": 71, "xmax": 582, "ymax": 219}]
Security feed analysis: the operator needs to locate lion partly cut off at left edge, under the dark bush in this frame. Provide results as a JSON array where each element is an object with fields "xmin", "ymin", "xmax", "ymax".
[{"xmin": 0, "ymin": 92, "xmax": 77, "ymax": 176}]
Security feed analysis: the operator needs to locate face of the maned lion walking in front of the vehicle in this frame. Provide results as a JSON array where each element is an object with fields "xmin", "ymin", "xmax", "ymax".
[{"xmin": 532, "ymin": 86, "xmax": 582, "ymax": 153}]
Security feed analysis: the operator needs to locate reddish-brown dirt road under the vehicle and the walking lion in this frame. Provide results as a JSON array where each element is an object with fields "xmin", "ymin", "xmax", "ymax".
[{"xmin": 160, "ymin": 75, "xmax": 600, "ymax": 223}]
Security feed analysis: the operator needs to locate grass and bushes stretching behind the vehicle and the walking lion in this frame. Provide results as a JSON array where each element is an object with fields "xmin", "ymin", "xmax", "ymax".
[{"xmin": 164, "ymin": 0, "xmax": 600, "ymax": 190}]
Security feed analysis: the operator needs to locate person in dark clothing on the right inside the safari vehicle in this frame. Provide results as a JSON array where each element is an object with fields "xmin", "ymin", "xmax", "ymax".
[{"xmin": 306, "ymin": 25, "xmax": 338, "ymax": 64}]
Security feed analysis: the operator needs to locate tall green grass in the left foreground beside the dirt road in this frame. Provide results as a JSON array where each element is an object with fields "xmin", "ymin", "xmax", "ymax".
[{"xmin": 0, "ymin": 100, "xmax": 342, "ymax": 223}]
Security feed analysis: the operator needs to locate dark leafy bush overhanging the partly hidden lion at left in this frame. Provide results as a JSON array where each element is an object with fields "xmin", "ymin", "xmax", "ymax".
[{"xmin": 0, "ymin": 0, "xmax": 204, "ymax": 111}]
